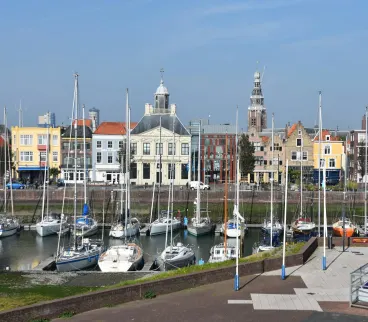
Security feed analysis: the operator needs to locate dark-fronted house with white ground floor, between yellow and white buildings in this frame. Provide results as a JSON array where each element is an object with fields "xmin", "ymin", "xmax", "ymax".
[{"xmin": 60, "ymin": 120, "xmax": 92, "ymax": 183}]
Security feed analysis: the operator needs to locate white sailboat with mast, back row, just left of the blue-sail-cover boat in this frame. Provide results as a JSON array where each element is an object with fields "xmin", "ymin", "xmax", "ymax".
[{"xmin": 36, "ymin": 113, "xmax": 69, "ymax": 237}]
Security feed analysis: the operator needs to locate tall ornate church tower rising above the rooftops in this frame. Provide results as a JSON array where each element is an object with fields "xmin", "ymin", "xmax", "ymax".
[{"xmin": 248, "ymin": 71, "xmax": 267, "ymax": 132}]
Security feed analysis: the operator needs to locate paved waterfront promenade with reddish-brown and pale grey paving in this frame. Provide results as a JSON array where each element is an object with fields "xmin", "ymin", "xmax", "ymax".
[{"xmin": 53, "ymin": 247, "xmax": 368, "ymax": 322}]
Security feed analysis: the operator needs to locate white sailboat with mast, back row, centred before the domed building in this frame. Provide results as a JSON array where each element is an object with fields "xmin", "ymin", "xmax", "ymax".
[{"xmin": 147, "ymin": 117, "xmax": 181, "ymax": 236}]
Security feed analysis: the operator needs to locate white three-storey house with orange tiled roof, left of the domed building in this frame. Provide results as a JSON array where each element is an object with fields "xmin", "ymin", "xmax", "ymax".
[{"xmin": 92, "ymin": 122, "xmax": 137, "ymax": 184}]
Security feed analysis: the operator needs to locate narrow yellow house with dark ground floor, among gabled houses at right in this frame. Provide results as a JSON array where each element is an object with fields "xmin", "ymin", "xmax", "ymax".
[{"xmin": 313, "ymin": 130, "xmax": 346, "ymax": 185}]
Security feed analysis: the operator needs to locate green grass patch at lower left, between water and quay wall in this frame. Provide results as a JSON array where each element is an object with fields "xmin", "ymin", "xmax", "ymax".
[{"xmin": 0, "ymin": 272, "xmax": 99, "ymax": 311}]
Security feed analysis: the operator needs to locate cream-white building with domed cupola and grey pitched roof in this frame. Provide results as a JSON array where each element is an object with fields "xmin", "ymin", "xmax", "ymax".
[{"xmin": 130, "ymin": 78, "xmax": 191, "ymax": 186}]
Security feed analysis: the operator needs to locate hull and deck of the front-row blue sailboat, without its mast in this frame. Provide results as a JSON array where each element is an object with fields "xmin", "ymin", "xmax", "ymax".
[{"xmin": 55, "ymin": 238, "xmax": 104, "ymax": 272}]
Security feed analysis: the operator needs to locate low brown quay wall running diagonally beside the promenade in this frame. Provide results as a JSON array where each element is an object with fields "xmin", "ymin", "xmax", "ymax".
[{"xmin": 0, "ymin": 238, "xmax": 318, "ymax": 322}]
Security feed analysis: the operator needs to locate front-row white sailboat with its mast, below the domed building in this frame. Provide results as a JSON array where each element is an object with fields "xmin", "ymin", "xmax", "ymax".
[{"xmin": 156, "ymin": 117, "xmax": 196, "ymax": 271}]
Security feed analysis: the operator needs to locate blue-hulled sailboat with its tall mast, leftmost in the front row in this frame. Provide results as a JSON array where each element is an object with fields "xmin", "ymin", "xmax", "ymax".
[{"xmin": 55, "ymin": 74, "xmax": 104, "ymax": 272}]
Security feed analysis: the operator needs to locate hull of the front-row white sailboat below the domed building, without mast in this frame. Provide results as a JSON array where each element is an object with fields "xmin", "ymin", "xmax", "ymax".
[{"xmin": 156, "ymin": 243, "xmax": 196, "ymax": 271}]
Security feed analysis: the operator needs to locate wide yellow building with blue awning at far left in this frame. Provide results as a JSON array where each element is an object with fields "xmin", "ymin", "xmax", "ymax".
[{"xmin": 11, "ymin": 126, "xmax": 61, "ymax": 183}]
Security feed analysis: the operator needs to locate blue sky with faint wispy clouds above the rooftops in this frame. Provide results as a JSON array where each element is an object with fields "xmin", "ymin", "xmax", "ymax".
[{"xmin": 0, "ymin": 0, "xmax": 368, "ymax": 129}]
